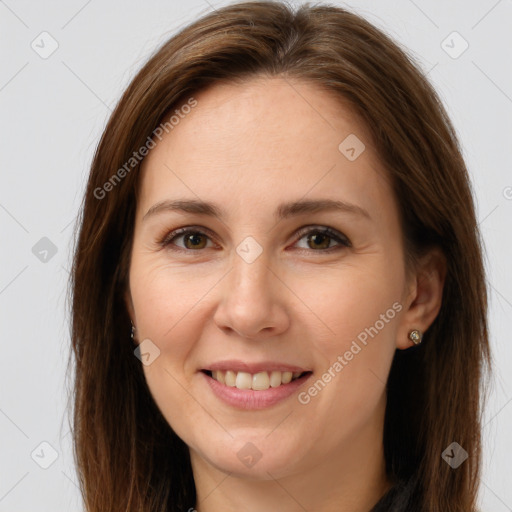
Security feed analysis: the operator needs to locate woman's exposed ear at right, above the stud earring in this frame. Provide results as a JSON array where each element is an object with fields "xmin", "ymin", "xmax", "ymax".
[{"xmin": 396, "ymin": 247, "xmax": 446, "ymax": 350}]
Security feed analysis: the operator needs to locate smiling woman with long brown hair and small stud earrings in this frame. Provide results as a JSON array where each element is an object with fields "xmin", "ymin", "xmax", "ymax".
[{"xmin": 67, "ymin": 2, "xmax": 489, "ymax": 512}]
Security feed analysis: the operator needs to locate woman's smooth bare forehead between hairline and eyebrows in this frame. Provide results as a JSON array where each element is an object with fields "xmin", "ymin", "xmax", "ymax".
[{"xmin": 141, "ymin": 78, "xmax": 390, "ymax": 221}]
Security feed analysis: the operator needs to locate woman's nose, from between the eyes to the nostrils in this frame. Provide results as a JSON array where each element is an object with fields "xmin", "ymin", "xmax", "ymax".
[{"xmin": 214, "ymin": 248, "xmax": 291, "ymax": 339}]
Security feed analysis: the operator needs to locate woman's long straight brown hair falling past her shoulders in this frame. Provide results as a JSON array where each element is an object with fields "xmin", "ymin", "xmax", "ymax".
[{"xmin": 66, "ymin": 2, "xmax": 491, "ymax": 512}]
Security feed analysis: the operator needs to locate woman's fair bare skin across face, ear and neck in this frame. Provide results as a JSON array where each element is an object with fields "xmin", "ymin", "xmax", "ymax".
[{"xmin": 126, "ymin": 78, "xmax": 445, "ymax": 512}]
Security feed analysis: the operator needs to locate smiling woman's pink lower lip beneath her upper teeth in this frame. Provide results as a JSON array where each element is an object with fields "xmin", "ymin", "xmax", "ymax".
[{"xmin": 199, "ymin": 372, "xmax": 312, "ymax": 410}]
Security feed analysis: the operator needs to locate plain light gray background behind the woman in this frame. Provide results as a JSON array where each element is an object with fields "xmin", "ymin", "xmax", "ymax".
[{"xmin": 0, "ymin": 0, "xmax": 512, "ymax": 512}]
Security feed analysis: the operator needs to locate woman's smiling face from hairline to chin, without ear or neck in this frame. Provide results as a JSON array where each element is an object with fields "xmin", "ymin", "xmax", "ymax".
[{"xmin": 127, "ymin": 78, "xmax": 416, "ymax": 479}]
